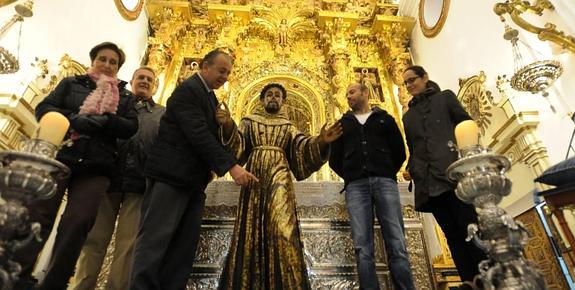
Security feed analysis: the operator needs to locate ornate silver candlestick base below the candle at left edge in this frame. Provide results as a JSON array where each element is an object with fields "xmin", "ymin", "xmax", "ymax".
[{"xmin": 0, "ymin": 139, "xmax": 70, "ymax": 290}]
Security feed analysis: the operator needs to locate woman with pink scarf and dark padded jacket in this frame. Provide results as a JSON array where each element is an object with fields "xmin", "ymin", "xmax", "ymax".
[{"xmin": 13, "ymin": 42, "xmax": 138, "ymax": 289}]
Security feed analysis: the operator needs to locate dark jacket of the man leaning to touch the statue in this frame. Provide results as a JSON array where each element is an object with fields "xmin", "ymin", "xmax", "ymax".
[{"xmin": 145, "ymin": 74, "xmax": 236, "ymax": 190}]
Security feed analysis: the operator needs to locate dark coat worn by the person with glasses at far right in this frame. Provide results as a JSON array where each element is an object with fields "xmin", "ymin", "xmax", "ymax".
[{"xmin": 403, "ymin": 90, "xmax": 471, "ymax": 211}]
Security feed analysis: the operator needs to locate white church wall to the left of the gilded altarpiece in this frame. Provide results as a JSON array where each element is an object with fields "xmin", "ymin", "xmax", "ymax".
[{"xmin": 0, "ymin": 0, "xmax": 147, "ymax": 95}]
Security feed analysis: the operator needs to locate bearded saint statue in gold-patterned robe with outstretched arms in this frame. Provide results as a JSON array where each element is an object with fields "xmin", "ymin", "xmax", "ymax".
[{"xmin": 216, "ymin": 84, "xmax": 342, "ymax": 290}]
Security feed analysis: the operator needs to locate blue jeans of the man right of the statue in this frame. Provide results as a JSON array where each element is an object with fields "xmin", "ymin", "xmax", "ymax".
[{"xmin": 345, "ymin": 177, "xmax": 415, "ymax": 290}]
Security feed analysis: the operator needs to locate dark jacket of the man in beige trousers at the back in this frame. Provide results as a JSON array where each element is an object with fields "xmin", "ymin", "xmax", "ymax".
[{"xmin": 110, "ymin": 99, "xmax": 166, "ymax": 193}]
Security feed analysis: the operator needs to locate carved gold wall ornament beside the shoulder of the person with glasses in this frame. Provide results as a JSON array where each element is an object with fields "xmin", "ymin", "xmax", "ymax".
[{"xmin": 457, "ymin": 71, "xmax": 493, "ymax": 134}]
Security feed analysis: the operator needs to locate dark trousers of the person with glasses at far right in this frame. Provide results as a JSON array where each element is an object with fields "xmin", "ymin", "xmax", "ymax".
[{"xmin": 430, "ymin": 190, "xmax": 487, "ymax": 281}]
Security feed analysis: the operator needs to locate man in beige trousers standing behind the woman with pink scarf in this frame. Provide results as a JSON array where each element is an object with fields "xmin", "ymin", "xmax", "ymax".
[{"xmin": 69, "ymin": 67, "xmax": 166, "ymax": 290}]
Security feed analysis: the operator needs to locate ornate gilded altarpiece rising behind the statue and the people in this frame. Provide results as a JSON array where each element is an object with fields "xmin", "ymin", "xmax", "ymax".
[{"xmin": 147, "ymin": 0, "xmax": 415, "ymax": 134}]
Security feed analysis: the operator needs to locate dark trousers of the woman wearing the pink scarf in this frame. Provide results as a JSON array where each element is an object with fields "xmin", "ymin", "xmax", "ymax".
[{"xmin": 39, "ymin": 174, "xmax": 110, "ymax": 290}]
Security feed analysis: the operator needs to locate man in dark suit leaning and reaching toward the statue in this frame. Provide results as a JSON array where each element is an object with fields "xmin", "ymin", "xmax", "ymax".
[{"xmin": 130, "ymin": 50, "xmax": 257, "ymax": 290}]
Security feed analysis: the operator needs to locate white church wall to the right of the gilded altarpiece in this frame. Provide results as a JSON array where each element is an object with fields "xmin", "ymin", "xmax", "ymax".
[{"xmin": 400, "ymin": 0, "xmax": 575, "ymax": 214}]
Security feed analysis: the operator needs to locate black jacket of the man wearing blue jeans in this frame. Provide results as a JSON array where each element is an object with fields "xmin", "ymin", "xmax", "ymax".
[{"xmin": 329, "ymin": 107, "xmax": 406, "ymax": 184}]
